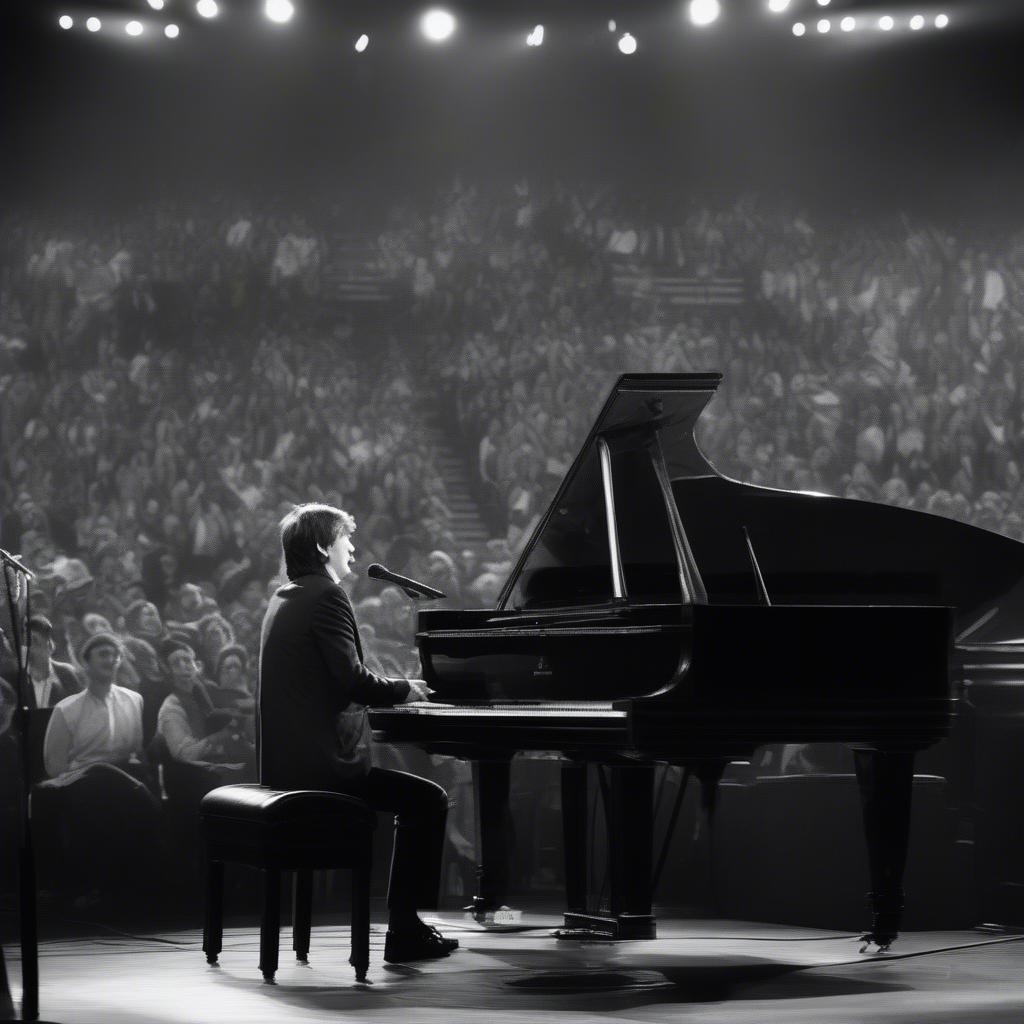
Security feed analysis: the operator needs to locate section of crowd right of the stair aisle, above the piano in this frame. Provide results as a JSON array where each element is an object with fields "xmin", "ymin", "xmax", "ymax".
[{"xmin": 376, "ymin": 184, "xmax": 1024, "ymax": 539}]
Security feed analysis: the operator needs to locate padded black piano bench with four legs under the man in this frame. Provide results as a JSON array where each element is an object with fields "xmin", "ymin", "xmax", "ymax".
[{"xmin": 200, "ymin": 784, "xmax": 377, "ymax": 982}]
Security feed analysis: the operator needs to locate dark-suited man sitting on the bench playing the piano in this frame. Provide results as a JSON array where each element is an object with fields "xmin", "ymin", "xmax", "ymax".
[{"xmin": 257, "ymin": 504, "xmax": 459, "ymax": 964}]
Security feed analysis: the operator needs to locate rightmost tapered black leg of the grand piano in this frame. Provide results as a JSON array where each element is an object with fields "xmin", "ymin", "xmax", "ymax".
[{"xmin": 853, "ymin": 749, "xmax": 914, "ymax": 948}]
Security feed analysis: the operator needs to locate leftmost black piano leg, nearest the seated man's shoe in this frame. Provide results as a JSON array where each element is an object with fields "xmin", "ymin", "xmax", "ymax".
[{"xmin": 466, "ymin": 757, "xmax": 513, "ymax": 919}]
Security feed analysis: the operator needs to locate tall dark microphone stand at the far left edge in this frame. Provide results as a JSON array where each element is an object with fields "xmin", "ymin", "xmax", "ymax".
[{"xmin": 0, "ymin": 548, "xmax": 57, "ymax": 1021}]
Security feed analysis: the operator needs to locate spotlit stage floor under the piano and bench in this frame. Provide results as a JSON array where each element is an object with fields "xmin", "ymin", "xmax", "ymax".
[{"xmin": 6, "ymin": 913, "xmax": 1024, "ymax": 1024}]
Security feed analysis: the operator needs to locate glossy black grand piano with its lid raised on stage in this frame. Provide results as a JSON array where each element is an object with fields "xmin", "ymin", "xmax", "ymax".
[{"xmin": 370, "ymin": 374, "xmax": 1024, "ymax": 948}]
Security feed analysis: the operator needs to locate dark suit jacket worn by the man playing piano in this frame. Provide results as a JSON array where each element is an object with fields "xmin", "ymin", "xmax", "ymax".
[{"xmin": 257, "ymin": 572, "xmax": 409, "ymax": 790}]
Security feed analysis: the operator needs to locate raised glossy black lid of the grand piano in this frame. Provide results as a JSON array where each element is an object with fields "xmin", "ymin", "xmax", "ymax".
[{"xmin": 498, "ymin": 374, "xmax": 1024, "ymax": 648}]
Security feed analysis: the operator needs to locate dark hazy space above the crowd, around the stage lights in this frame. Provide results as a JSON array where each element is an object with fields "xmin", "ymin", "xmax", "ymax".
[{"xmin": 6, "ymin": 0, "xmax": 1024, "ymax": 219}]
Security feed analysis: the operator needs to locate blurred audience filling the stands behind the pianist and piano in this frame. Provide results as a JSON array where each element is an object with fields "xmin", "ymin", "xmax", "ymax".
[{"xmin": 0, "ymin": 182, "xmax": 1024, "ymax": 913}]
